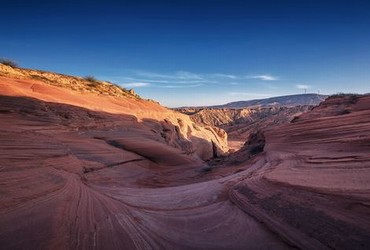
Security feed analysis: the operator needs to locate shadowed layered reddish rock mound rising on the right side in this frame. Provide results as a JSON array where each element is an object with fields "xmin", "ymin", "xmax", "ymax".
[{"xmin": 230, "ymin": 96, "xmax": 370, "ymax": 249}]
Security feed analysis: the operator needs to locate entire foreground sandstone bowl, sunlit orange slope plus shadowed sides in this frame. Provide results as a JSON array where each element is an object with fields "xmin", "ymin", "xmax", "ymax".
[{"xmin": 0, "ymin": 66, "xmax": 370, "ymax": 249}]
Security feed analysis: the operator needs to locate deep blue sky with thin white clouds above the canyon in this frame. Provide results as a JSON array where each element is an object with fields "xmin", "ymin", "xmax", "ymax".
[{"xmin": 0, "ymin": 0, "xmax": 370, "ymax": 107}]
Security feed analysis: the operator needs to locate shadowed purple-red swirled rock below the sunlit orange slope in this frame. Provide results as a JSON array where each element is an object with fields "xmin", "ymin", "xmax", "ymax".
[{"xmin": 0, "ymin": 93, "xmax": 286, "ymax": 249}]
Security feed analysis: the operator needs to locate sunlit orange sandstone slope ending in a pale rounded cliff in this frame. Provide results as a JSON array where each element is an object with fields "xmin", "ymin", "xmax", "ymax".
[{"xmin": 0, "ymin": 64, "xmax": 228, "ymax": 159}]
